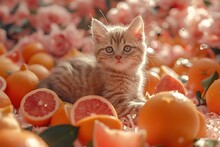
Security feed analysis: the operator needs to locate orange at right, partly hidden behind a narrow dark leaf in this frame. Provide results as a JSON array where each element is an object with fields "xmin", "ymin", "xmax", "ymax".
[{"xmin": 187, "ymin": 58, "xmax": 220, "ymax": 93}]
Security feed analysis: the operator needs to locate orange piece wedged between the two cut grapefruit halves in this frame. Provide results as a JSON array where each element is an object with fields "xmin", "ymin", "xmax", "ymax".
[{"xmin": 50, "ymin": 102, "xmax": 73, "ymax": 126}]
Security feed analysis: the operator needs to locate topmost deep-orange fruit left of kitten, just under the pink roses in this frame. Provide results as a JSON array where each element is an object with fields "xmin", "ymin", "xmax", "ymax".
[{"xmin": 22, "ymin": 42, "xmax": 45, "ymax": 63}]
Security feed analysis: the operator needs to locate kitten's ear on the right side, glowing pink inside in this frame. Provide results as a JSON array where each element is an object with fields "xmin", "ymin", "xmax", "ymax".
[{"xmin": 127, "ymin": 16, "xmax": 144, "ymax": 40}]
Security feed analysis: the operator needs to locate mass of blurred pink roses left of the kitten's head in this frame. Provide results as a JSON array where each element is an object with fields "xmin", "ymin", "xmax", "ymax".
[{"xmin": 0, "ymin": 0, "xmax": 117, "ymax": 57}]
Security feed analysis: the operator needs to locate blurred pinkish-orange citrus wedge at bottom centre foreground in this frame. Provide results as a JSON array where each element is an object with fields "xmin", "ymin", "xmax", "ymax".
[{"xmin": 93, "ymin": 121, "xmax": 146, "ymax": 147}]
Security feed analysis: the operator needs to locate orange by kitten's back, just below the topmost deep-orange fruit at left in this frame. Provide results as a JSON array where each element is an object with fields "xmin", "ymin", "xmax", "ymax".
[{"xmin": 28, "ymin": 53, "xmax": 55, "ymax": 70}]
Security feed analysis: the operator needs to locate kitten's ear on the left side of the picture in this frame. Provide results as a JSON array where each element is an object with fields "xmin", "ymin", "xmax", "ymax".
[{"xmin": 91, "ymin": 18, "xmax": 108, "ymax": 42}]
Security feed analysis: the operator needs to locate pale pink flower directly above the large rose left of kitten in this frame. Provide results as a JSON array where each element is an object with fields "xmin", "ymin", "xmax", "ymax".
[{"xmin": 36, "ymin": 4, "xmax": 71, "ymax": 32}]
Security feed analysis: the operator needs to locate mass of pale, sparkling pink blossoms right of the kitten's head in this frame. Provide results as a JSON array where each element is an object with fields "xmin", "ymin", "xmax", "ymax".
[{"xmin": 107, "ymin": 0, "xmax": 220, "ymax": 65}]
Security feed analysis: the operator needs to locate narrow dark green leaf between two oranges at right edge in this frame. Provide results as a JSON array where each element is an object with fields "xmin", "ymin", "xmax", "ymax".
[{"xmin": 202, "ymin": 71, "xmax": 218, "ymax": 97}]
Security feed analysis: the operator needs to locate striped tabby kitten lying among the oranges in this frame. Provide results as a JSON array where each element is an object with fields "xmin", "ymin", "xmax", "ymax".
[{"xmin": 40, "ymin": 16, "xmax": 146, "ymax": 117}]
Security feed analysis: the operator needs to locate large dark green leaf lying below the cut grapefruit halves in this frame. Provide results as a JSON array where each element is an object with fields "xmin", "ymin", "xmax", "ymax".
[{"xmin": 39, "ymin": 125, "xmax": 79, "ymax": 147}]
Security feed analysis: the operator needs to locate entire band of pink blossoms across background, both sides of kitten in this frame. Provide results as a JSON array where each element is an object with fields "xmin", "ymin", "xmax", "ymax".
[{"xmin": 0, "ymin": 0, "xmax": 220, "ymax": 58}]
